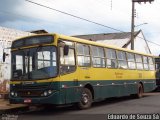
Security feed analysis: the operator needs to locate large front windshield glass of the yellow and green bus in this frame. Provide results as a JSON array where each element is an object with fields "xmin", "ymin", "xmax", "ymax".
[{"xmin": 12, "ymin": 46, "xmax": 57, "ymax": 80}]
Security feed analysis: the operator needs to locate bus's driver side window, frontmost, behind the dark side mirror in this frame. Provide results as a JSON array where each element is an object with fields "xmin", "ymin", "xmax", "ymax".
[{"xmin": 59, "ymin": 41, "xmax": 76, "ymax": 74}]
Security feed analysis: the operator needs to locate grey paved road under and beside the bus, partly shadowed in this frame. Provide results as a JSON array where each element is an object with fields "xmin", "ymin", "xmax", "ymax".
[{"xmin": 2, "ymin": 92, "xmax": 160, "ymax": 120}]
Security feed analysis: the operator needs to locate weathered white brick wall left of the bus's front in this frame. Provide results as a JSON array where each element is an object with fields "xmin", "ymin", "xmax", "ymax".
[{"xmin": 0, "ymin": 27, "xmax": 33, "ymax": 92}]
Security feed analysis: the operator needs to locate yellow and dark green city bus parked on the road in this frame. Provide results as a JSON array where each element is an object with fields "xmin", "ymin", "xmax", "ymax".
[{"xmin": 10, "ymin": 34, "xmax": 156, "ymax": 109}]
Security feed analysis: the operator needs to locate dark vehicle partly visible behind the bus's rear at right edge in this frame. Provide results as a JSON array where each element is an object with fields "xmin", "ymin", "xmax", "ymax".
[{"xmin": 155, "ymin": 57, "xmax": 160, "ymax": 86}]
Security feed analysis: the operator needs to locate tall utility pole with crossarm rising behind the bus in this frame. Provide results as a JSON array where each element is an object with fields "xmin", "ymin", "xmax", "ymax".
[{"xmin": 131, "ymin": 0, "xmax": 154, "ymax": 50}]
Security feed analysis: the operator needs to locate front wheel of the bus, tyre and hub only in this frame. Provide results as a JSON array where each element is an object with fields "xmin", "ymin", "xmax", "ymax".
[{"xmin": 78, "ymin": 88, "xmax": 92, "ymax": 110}]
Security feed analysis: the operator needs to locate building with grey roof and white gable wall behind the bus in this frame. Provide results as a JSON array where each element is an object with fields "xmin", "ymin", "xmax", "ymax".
[{"xmin": 74, "ymin": 30, "xmax": 151, "ymax": 54}]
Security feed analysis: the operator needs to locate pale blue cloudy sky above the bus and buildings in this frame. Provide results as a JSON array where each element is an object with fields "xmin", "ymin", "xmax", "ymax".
[{"xmin": 0, "ymin": 0, "xmax": 160, "ymax": 55}]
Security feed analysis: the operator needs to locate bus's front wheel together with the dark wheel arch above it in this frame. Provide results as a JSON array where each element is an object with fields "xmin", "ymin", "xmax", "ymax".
[{"xmin": 78, "ymin": 84, "xmax": 94, "ymax": 110}]
